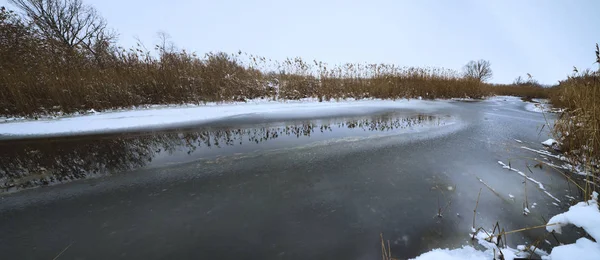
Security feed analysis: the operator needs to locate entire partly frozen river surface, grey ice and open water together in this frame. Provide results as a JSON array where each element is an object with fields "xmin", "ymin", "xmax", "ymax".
[{"xmin": 0, "ymin": 100, "xmax": 577, "ymax": 259}]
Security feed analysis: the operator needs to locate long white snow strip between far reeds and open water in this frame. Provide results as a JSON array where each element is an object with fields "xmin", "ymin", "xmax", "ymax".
[{"xmin": 0, "ymin": 99, "xmax": 452, "ymax": 137}]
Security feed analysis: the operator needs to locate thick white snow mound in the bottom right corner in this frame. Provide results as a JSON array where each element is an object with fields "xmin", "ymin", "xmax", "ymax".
[{"xmin": 544, "ymin": 191, "xmax": 600, "ymax": 260}]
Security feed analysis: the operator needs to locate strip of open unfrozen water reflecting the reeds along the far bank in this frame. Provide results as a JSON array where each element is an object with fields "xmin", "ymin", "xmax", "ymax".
[{"xmin": 0, "ymin": 112, "xmax": 455, "ymax": 191}]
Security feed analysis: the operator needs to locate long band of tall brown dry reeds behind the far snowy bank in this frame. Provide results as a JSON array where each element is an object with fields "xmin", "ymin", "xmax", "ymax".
[{"xmin": 0, "ymin": 7, "xmax": 485, "ymax": 117}]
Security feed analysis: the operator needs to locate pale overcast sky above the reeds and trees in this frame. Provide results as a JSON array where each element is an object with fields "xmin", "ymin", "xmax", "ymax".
[{"xmin": 0, "ymin": 0, "xmax": 600, "ymax": 84}]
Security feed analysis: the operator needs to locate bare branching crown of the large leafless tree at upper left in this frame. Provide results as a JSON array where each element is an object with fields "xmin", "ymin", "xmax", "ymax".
[{"xmin": 9, "ymin": 0, "xmax": 116, "ymax": 56}]
